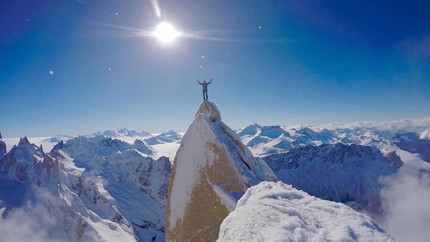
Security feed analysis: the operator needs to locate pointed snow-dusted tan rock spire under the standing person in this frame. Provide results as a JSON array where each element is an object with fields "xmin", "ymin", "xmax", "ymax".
[{"xmin": 166, "ymin": 101, "xmax": 276, "ymax": 241}]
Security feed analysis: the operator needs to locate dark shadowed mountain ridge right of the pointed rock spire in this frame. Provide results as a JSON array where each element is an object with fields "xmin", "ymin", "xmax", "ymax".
[{"xmin": 264, "ymin": 144, "xmax": 403, "ymax": 213}]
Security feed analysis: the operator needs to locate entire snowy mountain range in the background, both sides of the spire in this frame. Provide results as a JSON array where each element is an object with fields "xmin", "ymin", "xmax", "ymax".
[{"xmin": 0, "ymin": 117, "xmax": 430, "ymax": 241}]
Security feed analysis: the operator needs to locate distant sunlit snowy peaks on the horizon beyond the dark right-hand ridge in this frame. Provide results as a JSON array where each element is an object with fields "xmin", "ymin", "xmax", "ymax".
[{"xmin": 237, "ymin": 118, "xmax": 430, "ymax": 157}]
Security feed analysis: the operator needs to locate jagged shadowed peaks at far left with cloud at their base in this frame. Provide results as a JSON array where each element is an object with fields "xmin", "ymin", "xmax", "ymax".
[{"xmin": 0, "ymin": 137, "xmax": 135, "ymax": 241}]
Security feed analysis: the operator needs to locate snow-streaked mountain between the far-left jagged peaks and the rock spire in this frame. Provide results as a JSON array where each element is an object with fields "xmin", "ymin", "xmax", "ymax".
[{"xmin": 53, "ymin": 136, "xmax": 171, "ymax": 241}]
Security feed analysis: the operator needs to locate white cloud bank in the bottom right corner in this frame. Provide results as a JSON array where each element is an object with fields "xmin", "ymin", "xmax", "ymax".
[{"xmin": 381, "ymin": 167, "xmax": 430, "ymax": 242}]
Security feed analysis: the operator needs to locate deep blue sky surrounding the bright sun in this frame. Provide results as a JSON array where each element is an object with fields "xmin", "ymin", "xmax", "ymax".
[{"xmin": 0, "ymin": 0, "xmax": 430, "ymax": 137}]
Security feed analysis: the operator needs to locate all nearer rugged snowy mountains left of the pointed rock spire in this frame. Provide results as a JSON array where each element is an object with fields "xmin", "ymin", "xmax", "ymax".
[{"xmin": 0, "ymin": 136, "xmax": 171, "ymax": 241}]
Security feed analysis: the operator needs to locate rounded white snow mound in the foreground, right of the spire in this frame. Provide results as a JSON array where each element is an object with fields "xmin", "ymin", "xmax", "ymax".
[{"xmin": 218, "ymin": 182, "xmax": 394, "ymax": 242}]
